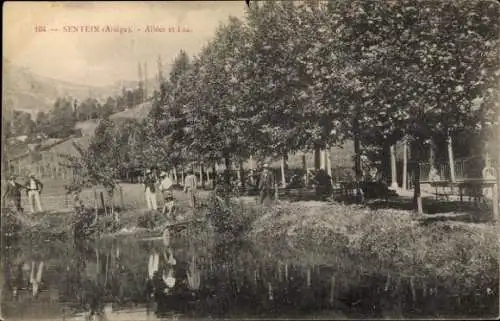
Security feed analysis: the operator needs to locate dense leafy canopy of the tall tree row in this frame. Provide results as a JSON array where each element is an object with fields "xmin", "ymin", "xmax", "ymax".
[{"xmin": 100, "ymin": 0, "xmax": 500, "ymax": 175}]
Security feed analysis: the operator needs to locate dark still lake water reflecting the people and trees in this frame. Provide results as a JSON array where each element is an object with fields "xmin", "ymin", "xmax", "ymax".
[{"xmin": 2, "ymin": 215, "xmax": 498, "ymax": 320}]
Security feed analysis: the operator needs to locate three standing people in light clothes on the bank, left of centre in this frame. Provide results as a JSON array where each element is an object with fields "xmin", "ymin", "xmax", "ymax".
[{"xmin": 143, "ymin": 169, "xmax": 198, "ymax": 216}]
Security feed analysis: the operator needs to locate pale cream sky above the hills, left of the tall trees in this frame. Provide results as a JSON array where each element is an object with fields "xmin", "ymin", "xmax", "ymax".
[{"xmin": 2, "ymin": 0, "xmax": 246, "ymax": 86}]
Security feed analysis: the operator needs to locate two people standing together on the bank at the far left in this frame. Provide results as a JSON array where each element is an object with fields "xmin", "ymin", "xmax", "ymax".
[{"xmin": 2, "ymin": 174, "xmax": 43, "ymax": 213}]
